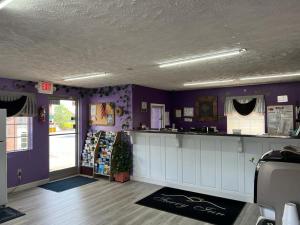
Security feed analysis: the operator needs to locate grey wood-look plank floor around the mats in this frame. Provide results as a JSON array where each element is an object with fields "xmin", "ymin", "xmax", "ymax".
[{"xmin": 4, "ymin": 179, "xmax": 258, "ymax": 225}]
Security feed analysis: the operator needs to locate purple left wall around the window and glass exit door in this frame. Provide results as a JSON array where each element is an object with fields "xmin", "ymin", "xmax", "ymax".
[{"xmin": 0, "ymin": 78, "xmax": 88, "ymax": 187}]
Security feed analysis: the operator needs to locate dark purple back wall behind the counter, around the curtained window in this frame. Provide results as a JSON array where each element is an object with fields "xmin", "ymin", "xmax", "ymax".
[{"xmin": 172, "ymin": 82, "xmax": 300, "ymax": 132}]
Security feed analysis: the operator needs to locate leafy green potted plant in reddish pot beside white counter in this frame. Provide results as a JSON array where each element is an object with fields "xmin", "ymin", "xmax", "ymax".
[{"xmin": 111, "ymin": 135, "xmax": 132, "ymax": 183}]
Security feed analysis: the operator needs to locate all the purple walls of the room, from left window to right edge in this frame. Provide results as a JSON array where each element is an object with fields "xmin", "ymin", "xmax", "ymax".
[{"xmin": 0, "ymin": 78, "xmax": 300, "ymax": 187}]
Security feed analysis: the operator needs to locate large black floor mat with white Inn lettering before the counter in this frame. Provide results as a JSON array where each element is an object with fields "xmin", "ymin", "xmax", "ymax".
[{"xmin": 136, "ymin": 187, "xmax": 245, "ymax": 225}]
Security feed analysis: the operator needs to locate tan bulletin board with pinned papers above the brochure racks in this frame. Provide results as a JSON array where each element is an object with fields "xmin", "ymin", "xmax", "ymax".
[{"xmin": 90, "ymin": 102, "xmax": 115, "ymax": 126}]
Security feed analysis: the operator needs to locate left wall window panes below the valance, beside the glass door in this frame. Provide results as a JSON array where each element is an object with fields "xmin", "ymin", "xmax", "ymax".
[{"xmin": 6, "ymin": 117, "xmax": 32, "ymax": 152}]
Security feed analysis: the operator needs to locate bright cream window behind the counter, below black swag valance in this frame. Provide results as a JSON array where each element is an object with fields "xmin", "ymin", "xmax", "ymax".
[{"xmin": 227, "ymin": 111, "xmax": 265, "ymax": 135}]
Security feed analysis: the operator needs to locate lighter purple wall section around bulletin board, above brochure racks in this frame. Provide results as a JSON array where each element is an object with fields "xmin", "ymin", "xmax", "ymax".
[{"xmin": 87, "ymin": 85, "xmax": 132, "ymax": 131}]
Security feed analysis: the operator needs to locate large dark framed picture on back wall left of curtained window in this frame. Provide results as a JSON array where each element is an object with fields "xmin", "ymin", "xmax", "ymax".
[{"xmin": 195, "ymin": 96, "xmax": 218, "ymax": 121}]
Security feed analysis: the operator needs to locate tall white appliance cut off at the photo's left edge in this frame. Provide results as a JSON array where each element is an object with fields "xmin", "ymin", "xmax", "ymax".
[{"xmin": 0, "ymin": 109, "xmax": 7, "ymax": 206}]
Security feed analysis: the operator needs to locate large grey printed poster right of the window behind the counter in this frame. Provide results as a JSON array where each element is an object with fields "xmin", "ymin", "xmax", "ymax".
[{"xmin": 267, "ymin": 105, "xmax": 294, "ymax": 136}]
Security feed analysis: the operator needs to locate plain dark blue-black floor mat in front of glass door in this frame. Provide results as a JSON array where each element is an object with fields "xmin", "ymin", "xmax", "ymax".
[{"xmin": 39, "ymin": 176, "xmax": 97, "ymax": 192}]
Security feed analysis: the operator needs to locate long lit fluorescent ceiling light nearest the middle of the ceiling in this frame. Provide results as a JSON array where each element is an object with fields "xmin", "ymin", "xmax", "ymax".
[{"xmin": 158, "ymin": 48, "xmax": 247, "ymax": 68}]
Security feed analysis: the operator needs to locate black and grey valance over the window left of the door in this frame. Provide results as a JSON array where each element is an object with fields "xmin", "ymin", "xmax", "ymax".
[{"xmin": 0, "ymin": 91, "xmax": 37, "ymax": 117}]
